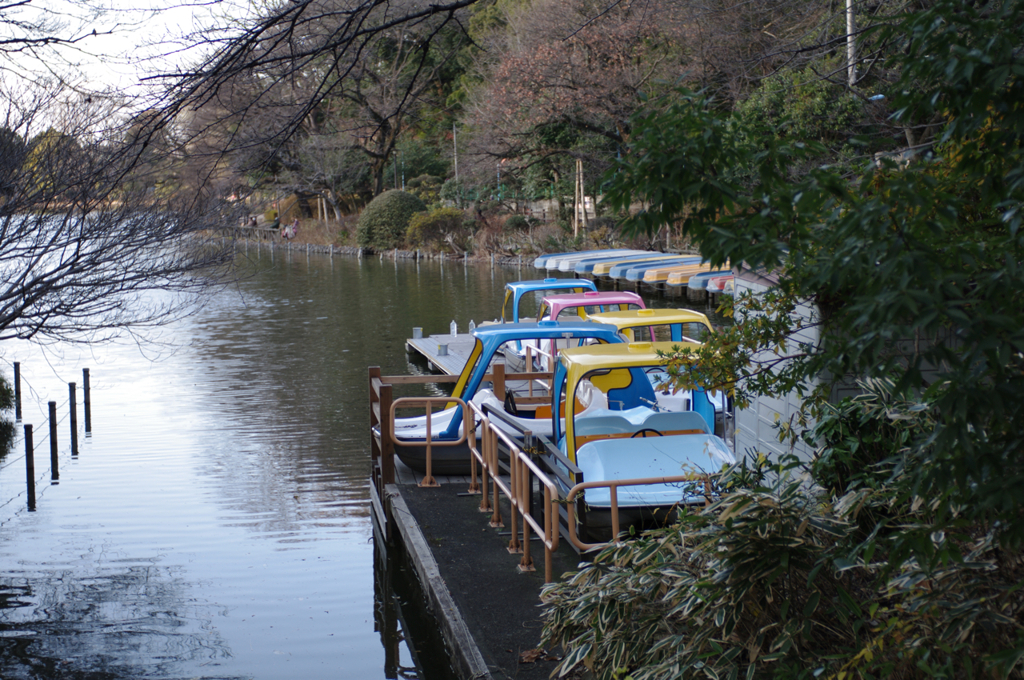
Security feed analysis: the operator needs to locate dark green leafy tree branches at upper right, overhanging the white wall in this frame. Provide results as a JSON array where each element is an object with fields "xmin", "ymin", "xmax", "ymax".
[{"xmin": 609, "ymin": 1, "xmax": 1024, "ymax": 559}]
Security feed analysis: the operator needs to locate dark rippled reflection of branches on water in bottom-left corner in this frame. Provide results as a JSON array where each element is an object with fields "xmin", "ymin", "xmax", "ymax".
[{"xmin": 0, "ymin": 564, "xmax": 238, "ymax": 680}]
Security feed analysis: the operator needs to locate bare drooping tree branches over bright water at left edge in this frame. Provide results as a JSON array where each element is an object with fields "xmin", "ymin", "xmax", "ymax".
[{"xmin": 0, "ymin": 80, "xmax": 233, "ymax": 342}]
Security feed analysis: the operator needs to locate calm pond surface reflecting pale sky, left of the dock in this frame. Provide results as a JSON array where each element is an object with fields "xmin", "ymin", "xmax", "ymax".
[{"xmin": 0, "ymin": 248, "xmax": 724, "ymax": 680}]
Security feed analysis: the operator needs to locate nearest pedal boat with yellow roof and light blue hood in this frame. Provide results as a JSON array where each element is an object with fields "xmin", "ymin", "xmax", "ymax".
[{"xmin": 552, "ymin": 342, "xmax": 735, "ymax": 540}]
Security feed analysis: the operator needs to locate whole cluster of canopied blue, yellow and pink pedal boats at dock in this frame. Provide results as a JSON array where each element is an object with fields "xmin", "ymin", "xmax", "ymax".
[{"xmin": 378, "ymin": 270, "xmax": 734, "ymax": 536}]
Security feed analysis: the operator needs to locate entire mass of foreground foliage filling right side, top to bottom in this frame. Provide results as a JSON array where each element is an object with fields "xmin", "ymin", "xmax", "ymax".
[{"xmin": 547, "ymin": 0, "xmax": 1024, "ymax": 679}]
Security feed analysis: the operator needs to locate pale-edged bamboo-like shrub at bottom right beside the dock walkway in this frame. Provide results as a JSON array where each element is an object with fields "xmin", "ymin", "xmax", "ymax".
[{"xmin": 542, "ymin": 395, "xmax": 1024, "ymax": 680}]
